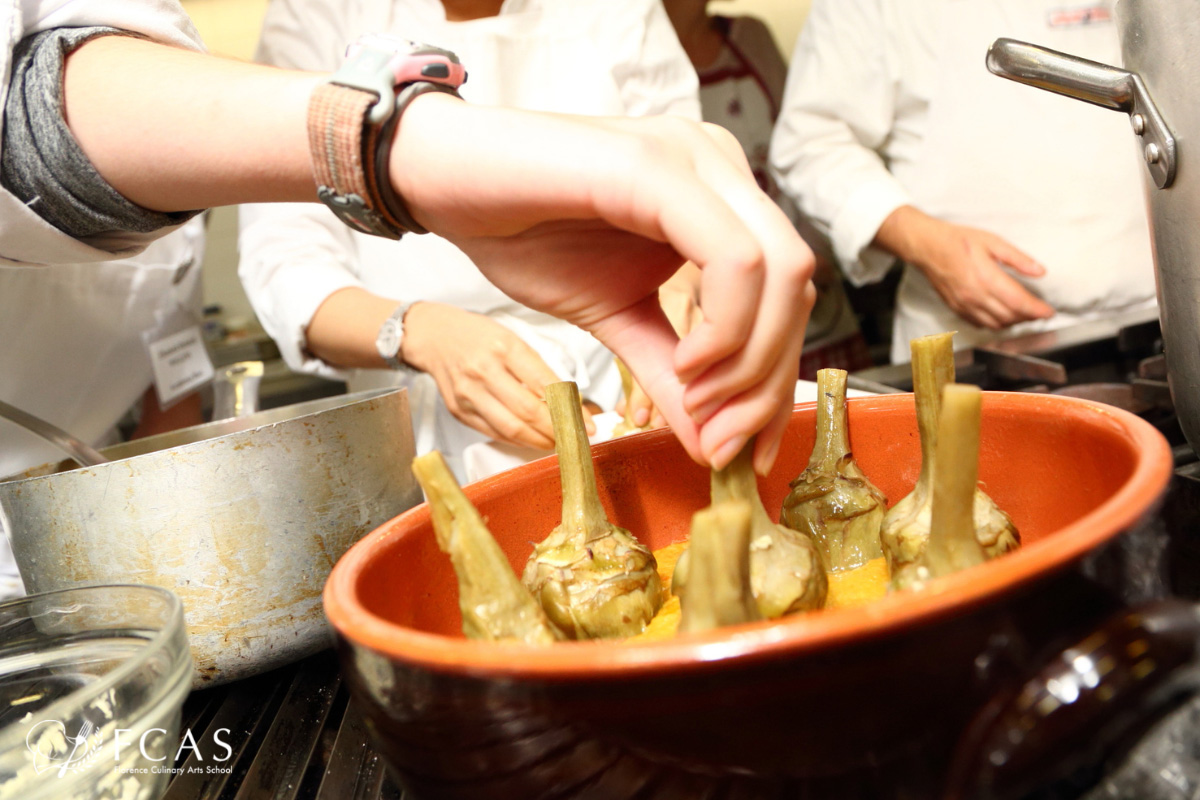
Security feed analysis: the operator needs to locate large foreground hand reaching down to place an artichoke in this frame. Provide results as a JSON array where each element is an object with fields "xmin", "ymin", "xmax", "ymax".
[{"xmin": 390, "ymin": 94, "xmax": 815, "ymax": 471}]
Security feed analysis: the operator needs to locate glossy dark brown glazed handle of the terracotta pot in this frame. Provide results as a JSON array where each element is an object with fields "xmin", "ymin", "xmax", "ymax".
[{"xmin": 946, "ymin": 599, "xmax": 1200, "ymax": 800}]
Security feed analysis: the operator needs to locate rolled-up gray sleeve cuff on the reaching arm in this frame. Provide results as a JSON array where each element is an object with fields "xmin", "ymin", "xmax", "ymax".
[{"xmin": 0, "ymin": 28, "xmax": 199, "ymax": 239}]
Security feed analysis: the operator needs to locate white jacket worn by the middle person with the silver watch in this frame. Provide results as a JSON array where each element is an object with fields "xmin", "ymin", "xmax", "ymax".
[{"xmin": 239, "ymin": 0, "xmax": 700, "ymax": 480}]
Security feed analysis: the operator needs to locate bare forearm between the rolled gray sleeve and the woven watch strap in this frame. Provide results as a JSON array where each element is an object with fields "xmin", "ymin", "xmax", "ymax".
[{"xmin": 64, "ymin": 36, "xmax": 320, "ymax": 211}]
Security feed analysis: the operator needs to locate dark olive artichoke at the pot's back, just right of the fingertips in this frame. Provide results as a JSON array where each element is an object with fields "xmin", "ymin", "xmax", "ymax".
[{"xmin": 780, "ymin": 369, "xmax": 887, "ymax": 572}]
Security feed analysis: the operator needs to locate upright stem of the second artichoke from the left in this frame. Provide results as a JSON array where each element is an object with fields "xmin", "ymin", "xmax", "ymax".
[{"xmin": 546, "ymin": 381, "xmax": 610, "ymax": 542}]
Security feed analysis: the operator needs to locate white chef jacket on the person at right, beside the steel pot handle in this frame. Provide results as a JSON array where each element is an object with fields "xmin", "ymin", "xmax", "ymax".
[{"xmin": 772, "ymin": 0, "xmax": 1154, "ymax": 361}]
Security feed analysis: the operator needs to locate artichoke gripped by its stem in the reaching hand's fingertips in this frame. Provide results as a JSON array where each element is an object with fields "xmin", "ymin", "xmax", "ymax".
[{"xmin": 671, "ymin": 439, "xmax": 829, "ymax": 619}]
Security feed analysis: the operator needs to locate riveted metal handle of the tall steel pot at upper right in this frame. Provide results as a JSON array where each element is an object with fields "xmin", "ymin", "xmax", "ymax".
[{"xmin": 988, "ymin": 38, "xmax": 1178, "ymax": 188}]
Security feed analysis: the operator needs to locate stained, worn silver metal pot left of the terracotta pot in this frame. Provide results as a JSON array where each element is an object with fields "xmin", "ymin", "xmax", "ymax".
[{"xmin": 0, "ymin": 390, "xmax": 421, "ymax": 687}]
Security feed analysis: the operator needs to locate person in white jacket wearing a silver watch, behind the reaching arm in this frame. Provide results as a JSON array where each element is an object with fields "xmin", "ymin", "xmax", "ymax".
[{"xmin": 239, "ymin": 0, "xmax": 700, "ymax": 481}]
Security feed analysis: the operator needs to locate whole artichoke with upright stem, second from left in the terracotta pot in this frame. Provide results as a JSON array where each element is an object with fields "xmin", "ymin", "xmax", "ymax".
[{"xmin": 522, "ymin": 381, "xmax": 662, "ymax": 639}]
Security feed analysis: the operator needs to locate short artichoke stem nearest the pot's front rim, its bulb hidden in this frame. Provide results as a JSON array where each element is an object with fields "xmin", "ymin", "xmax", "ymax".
[{"xmin": 679, "ymin": 500, "xmax": 762, "ymax": 632}]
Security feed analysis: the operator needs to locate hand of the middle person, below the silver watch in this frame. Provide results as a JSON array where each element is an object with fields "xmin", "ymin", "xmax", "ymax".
[{"xmin": 401, "ymin": 302, "xmax": 595, "ymax": 450}]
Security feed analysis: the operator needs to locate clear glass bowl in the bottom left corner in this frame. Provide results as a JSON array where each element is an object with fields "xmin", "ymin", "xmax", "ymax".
[{"xmin": 0, "ymin": 585, "xmax": 192, "ymax": 800}]
